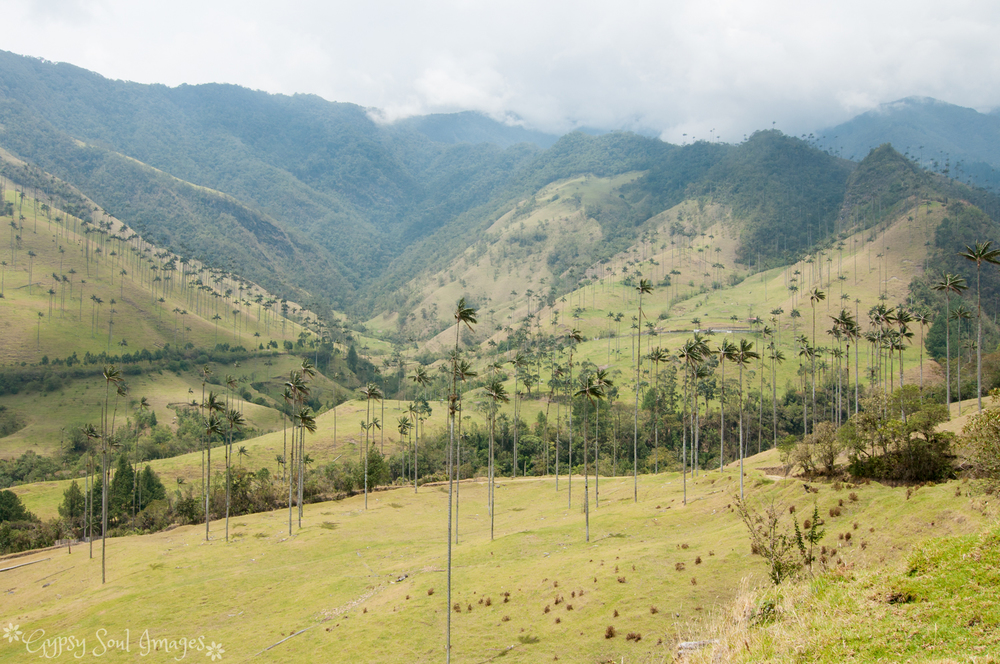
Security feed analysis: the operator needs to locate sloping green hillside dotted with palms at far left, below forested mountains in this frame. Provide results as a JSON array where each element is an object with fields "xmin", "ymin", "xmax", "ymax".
[{"xmin": 0, "ymin": 163, "xmax": 301, "ymax": 363}]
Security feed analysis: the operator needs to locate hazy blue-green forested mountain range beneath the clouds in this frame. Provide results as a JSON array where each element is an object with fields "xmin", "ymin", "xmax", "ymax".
[{"xmin": 0, "ymin": 52, "xmax": 1000, "ymax": 324}]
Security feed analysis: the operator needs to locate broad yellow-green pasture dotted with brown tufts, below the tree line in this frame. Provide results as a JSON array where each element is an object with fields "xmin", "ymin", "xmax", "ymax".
[{"xmin": 0, "ymin": 456, "xmax": 995, "ymax": 662}]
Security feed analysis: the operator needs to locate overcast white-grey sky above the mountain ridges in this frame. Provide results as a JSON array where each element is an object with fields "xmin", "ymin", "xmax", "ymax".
[{"xmin": 7, "ymin": 0, "xmax": 1000, "ymax": 142}]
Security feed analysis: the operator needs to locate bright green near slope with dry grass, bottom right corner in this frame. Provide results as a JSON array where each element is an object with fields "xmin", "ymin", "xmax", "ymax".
[{"xmin": 688, "ymin": 484, "xmax": 1000, "ymax": 662}]
